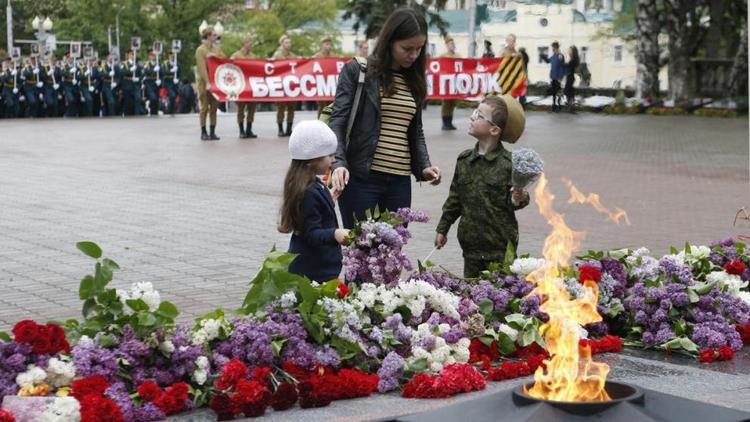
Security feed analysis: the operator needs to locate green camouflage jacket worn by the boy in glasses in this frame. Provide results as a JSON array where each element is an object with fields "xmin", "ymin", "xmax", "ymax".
[{"xmin": 437, "ymin": 144, "xmax": 529, "ymax": 261}]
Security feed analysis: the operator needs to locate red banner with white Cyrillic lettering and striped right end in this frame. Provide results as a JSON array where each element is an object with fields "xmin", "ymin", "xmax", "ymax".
[{"xmin": 208, "ymin": 57, "xmax": 526, "ymax": 102}]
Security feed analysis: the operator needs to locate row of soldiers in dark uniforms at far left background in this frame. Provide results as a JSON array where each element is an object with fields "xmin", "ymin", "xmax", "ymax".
[{"xmin": 0, "ymin": 49, "xmax": 196, "ymax": 118}]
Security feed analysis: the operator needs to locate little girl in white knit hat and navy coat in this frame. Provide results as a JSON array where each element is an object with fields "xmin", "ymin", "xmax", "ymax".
[{"xmin": 279, "ymin": 120, "xmax": 349, "ymax": 282}]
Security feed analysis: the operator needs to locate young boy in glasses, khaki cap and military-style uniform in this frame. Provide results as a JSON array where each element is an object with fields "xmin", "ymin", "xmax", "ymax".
[{"xmin": 435, "ymin": 95, "xmax": 529, "ymax": 278}]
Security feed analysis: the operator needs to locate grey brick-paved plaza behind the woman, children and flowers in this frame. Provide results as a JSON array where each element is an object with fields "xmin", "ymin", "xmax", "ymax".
[{"xmin": 0, "ymin": 107, "xmax": 750, "ymax": 330}]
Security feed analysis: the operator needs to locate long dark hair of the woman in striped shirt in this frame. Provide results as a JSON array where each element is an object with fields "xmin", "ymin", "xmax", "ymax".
[{"xmin": 371, "ymin": 7, "xmax": 427, "ymax": 104}]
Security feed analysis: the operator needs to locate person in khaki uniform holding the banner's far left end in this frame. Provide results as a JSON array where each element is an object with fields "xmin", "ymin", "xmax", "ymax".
[{"xmin": 195, "ymin": 26, "xmax": 224, "ymax": 141}]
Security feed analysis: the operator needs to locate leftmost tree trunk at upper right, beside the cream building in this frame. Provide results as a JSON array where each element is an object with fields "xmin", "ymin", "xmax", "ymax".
[{"xmin": 635, "ymin": 0, "xmax": 659, "ymax": 98}]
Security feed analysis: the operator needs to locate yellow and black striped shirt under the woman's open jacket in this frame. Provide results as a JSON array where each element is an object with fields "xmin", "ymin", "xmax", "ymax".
[{"xmin": 371, "ymin": 72, "xmax": 417, "ymax": 176}]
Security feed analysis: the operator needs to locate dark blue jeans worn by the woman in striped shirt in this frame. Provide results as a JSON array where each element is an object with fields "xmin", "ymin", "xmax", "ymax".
[{"xmin": 338, "ymin": 171, "xmax": 411, "ymax": 229}]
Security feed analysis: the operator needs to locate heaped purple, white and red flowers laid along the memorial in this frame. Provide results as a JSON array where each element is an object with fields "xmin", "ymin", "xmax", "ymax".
[{"xmin": 0, "ymin": 210, "xmax": 750, "ymax": 421}]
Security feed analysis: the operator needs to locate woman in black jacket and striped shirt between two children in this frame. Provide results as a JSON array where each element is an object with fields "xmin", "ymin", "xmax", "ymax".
[{"xmin": 330, "ymin": 8, "xmax": 441, "ymax": 228}]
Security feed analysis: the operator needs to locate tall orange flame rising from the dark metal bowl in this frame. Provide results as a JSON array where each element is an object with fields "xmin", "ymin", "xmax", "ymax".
[{"xmin": 524, "ymin": 175, "xmax": 609, "ymax": 401}]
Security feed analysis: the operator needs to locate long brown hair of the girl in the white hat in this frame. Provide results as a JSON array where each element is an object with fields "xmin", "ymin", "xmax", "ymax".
[{"xmin": 278, "ymin": 160, "xmax": 315, "ymax": 233}]
